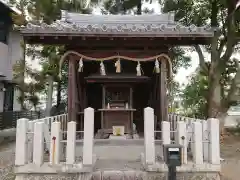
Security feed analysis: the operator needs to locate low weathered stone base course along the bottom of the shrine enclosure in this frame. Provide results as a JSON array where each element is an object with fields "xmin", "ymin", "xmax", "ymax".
[{"xmin": 16, "ymin": 170, "xmax": 220, "ymax": 180}]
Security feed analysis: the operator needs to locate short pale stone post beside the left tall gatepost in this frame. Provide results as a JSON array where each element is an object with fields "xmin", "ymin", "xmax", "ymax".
[{"xmin": 66, "ymin": 121, "xmax": 76, "ymax": 164}]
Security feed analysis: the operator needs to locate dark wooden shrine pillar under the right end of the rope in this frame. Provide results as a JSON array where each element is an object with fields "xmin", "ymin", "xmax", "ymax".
[{"xmin": 159, "ymin": 59, "xmax": 168, "ymax": 121}]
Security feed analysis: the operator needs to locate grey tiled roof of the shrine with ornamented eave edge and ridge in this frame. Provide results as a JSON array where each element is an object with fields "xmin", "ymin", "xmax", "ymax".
[{"xmin": 21, "ymin": 10, "xmax": 214, "ymax": 37}]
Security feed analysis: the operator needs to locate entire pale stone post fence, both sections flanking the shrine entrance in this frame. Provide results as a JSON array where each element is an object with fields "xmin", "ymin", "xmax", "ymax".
[{"xmin": 15, "ymin": 107, "xmax": 220, "ymax": 166}]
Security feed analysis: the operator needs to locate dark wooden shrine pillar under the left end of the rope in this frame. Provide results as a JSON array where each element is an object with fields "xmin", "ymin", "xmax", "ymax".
[{"xmin": 68, "ymin": 56, "xmax": 76, "ymax": 121}]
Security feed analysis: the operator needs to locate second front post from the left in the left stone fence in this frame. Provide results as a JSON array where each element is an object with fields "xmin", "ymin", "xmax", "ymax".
[{"xmin": 33, "ymin": 122, "xmax": 44, "ymax": 166}]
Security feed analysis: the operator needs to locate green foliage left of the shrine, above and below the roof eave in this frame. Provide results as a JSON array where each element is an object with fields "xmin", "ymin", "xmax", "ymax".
[{"xmin": 10, "ymin": 0, "xmax": 97, "ymax": 109}]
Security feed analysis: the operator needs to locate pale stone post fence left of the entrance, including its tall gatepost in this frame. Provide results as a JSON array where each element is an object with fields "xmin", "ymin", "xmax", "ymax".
[{"xmin": 15, "ymin": 108, "xmax": 94, "ymax": 166}]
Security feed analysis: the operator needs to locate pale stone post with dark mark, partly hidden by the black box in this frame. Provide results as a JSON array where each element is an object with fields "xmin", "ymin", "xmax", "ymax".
[{"xmin": 176, "ymin": 121, "xmax": 188, "ymax": 164}]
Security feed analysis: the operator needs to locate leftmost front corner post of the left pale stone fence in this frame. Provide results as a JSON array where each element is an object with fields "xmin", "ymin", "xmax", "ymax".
[{"xmin": 15, "ymin": 118, "xmax": 29, "ymax": 166}]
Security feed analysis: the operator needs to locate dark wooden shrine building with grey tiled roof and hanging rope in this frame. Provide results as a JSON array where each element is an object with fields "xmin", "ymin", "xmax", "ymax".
[{"xmin": 21, "ymin": 11, "xmax": 213, "ymax": 138}]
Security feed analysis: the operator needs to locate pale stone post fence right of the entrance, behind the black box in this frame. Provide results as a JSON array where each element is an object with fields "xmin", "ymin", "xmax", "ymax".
[{"xmin": 144, "ymin": 107, "xmax": 220, "ymax": 164}]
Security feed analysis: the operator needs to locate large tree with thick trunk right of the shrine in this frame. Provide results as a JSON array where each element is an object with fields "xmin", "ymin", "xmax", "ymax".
[{"xmin": 161, "ymin": 0, "xmax": 240, "ymax": 117}]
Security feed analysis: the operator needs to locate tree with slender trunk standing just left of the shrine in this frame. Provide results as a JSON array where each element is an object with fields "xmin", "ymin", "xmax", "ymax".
[{"xmin": 21, "ymin": 0, "xmax": 96, "ymax": 112}]
